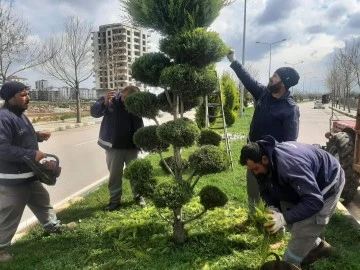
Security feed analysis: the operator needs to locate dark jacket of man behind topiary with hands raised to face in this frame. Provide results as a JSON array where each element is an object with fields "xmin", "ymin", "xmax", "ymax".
[{"xmin": 90, "ymin": 93, "xmax": 144, "ymax": 150}]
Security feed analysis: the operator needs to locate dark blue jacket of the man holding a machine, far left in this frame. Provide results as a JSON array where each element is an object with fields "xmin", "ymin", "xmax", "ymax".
[{"xmin": 0, "ymin": 103, "xmax": 39, "ymax": 186}]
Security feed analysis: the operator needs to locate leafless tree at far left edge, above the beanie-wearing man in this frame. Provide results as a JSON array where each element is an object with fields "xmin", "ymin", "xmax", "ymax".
[{"xmin": 0, "ymin": 0, "xmax": 53, "ymax": 83}]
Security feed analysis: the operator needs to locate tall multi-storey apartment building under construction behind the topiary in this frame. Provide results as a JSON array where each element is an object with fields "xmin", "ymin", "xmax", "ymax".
[{"xmin": 92, "ymin": 23, "xmax": 150, "ymax": 95}]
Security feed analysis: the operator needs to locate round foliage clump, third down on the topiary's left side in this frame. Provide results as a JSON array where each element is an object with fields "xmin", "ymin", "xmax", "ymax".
[{"xmin": 133, "ymin": 126, "xmax": 170, "ymax": 152}]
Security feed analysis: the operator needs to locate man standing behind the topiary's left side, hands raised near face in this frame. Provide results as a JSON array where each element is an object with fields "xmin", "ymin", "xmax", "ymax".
[{"xmin": 91, "ymin": 85, "xmax": 146, "ymax": 211}]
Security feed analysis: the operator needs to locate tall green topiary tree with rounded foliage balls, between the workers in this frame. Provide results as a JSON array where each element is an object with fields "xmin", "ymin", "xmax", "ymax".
[{"xmin": 121, "ymin": 0, "xmax": 232, "ymax": 243}]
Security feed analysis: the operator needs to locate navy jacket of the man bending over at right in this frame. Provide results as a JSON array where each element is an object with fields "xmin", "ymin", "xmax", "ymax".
[{"xmin": 257, "ymin": 136, "xmax": 340, "ymax": 224}]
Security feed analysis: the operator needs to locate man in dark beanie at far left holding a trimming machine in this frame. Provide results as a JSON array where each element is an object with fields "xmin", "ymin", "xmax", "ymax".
[{"xmin": 0, "ymin": 82, "xmax": 74, "ymax": 262}]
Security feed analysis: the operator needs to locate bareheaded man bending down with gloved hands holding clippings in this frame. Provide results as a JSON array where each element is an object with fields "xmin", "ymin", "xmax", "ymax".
[{"xmin": 240, "ymin": 136, "xmax": 345, "ymax": 266}]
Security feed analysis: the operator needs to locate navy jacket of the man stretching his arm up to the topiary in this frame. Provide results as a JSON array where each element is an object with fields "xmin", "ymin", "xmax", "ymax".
[{"xmin": 230, "ymin": 61, "xmax": 300, "ymax": 142}]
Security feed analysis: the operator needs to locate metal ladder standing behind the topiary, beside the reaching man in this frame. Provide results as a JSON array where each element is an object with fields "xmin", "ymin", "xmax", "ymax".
[{"xmin": 205, "ymin": 90, "xmax": 234, "ymax": 170}]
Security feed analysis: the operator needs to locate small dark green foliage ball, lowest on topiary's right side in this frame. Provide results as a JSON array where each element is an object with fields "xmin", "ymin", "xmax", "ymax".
[{"xmin": 199, "ymin": 185, "xmax": 228, "ymax": 209}]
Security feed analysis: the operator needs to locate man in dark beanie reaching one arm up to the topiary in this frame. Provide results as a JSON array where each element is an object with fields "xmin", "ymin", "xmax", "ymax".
[{"xmin": 227, "ymin": 50, "xmax": 300, "ymax": 225}]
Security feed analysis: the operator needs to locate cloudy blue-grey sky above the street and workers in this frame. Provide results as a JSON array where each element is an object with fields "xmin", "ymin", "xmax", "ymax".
[{"xmin": 5, "ymin": 0, "xmax": 360, "ymax": 93}]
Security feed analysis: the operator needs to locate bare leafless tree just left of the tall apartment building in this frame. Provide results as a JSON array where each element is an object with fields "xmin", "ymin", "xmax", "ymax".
[{"xmin": 41, "ymin": 16, "xmax": 93, "ymax": 123}]
